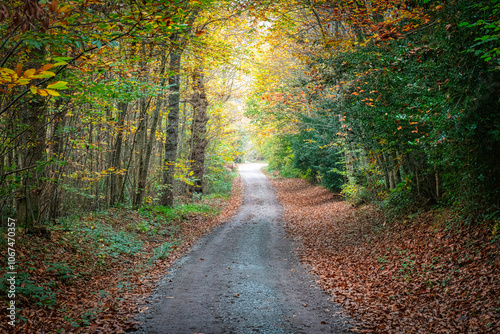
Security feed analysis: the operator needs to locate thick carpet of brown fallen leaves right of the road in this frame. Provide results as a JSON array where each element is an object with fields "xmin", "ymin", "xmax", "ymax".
[{"xmin": 272, "ymin": 179, "xmax": 500, "ymax": 333}]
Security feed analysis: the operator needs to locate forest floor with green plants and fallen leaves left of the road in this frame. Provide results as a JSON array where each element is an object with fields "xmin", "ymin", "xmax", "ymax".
[{"xmin": 0, "ymin": 177, "xmax": 242, "ymax": 334}]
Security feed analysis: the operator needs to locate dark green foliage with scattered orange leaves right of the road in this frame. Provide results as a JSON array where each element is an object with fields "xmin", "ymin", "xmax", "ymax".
[{"xmin": 254, "ymin": 0, "xmax": 500, "ymax": 222}]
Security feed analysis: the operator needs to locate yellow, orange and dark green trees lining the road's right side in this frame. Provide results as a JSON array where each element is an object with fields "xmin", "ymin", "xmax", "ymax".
[{"xmin": 247, "ymin": 1, "xmax": 499, "ymax": 219}]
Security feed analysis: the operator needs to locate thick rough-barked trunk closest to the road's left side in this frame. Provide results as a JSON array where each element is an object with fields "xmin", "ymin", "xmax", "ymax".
[{"xmin": 190, "ymin": 68, "xmax": 208, "ymax": 194}]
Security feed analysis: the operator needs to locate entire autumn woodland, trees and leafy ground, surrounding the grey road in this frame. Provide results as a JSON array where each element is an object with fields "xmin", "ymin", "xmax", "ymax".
[{"xmin": 0, "ymin": 0, "xmax": 500, "ymax": 333}]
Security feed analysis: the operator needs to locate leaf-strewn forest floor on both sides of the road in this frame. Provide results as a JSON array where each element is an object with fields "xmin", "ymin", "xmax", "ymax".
[{"xmin": 0, "ymin": 170, "xmax": 500, "ymax": 333}]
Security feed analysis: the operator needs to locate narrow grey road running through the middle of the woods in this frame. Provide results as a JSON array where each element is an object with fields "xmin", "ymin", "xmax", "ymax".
[{"xmin": 139, "ymin": 164, "xmax": 349, "ymax": 334}]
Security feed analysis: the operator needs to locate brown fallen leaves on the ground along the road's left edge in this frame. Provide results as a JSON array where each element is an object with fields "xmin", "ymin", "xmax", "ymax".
[{"xmin": 0, "ymin": 178, "xmax": 242, "ymax": 333}]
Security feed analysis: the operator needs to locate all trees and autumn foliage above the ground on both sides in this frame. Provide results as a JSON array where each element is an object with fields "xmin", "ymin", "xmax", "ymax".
[{"xmin": 0, "ymin": 0, "xmax": 500, "ymax": 225}]
